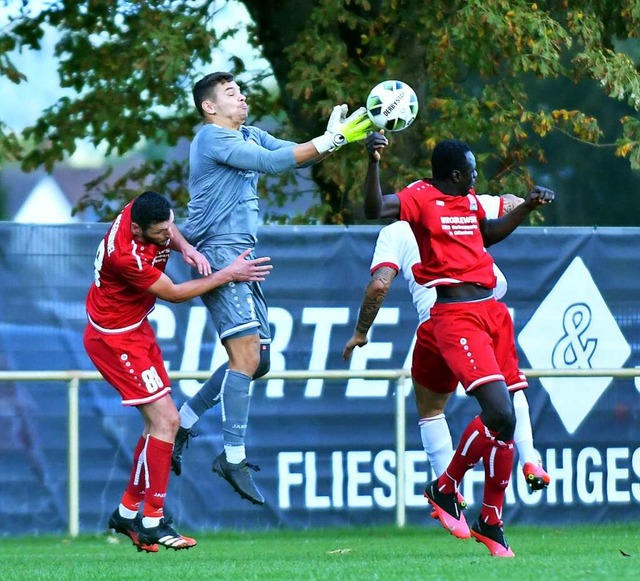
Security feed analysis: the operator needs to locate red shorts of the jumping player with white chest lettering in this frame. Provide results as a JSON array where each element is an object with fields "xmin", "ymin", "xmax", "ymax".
[{"xmin": 427, "ymin": 298, "xmax": 528, "ymax": 392}]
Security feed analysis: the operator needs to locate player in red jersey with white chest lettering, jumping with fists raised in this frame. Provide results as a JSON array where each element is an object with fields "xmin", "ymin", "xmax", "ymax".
[{"xmin": 364, "ymin": 132, "xmax": 554, "ymax": 557}]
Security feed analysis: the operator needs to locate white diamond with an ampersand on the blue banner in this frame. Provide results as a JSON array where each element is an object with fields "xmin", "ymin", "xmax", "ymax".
[{"xmin": 518, "ymin": 257, "xmax": 631, "ymax": 434}]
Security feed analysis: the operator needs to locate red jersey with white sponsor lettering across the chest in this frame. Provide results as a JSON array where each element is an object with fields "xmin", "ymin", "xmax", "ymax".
[{"xmin": 398, "ymin": 180, "xmax": 496, "ymax": 288}]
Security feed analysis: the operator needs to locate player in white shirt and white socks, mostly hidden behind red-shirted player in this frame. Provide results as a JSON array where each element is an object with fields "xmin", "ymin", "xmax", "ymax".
[{"xmin": 343, "ymin": 205, "xmax": 551, "ymax": 490}]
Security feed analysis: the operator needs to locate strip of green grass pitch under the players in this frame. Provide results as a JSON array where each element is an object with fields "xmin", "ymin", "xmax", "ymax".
[{"xmin": 0, "ymin": 523, "xmax": 640, "ymax": 581}]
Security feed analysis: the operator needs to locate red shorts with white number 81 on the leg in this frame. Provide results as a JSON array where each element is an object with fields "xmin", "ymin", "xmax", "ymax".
[{"xmin": 84, "ymin": 320, "xmax": 171, "ymax": 406}]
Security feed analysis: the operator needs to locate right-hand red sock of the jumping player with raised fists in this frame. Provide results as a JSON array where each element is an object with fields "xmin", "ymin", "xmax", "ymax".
[{"xmin": 480, "ymin": 440, "xmax": 514, "ymax": 525}]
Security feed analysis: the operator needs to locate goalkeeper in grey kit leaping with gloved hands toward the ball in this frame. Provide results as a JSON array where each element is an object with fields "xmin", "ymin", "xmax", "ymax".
[{"xmin": 172, "ymin": 72, "xmax": 373, "ymax": 504}]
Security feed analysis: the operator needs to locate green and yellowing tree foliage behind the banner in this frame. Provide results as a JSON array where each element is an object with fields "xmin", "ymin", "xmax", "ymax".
[{"xmin": 0, "ymin": 0, "xmax": 640, "ymax": 225}]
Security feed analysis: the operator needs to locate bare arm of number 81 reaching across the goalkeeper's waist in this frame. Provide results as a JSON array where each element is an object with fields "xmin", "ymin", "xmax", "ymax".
[{"xmin": 148, "ymin": 250, "xmax": 273, "ymax": 303}]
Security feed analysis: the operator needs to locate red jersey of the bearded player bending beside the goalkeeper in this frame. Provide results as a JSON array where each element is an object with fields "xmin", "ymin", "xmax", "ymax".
[{"xmin": 87, "ymin": 204, "xmax": 171, "ymax": 333}]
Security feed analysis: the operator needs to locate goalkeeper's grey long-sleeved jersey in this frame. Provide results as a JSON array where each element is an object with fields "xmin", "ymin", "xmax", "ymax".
[{"xmin": 183, "ymin": 124, "xmax": 296, "ymax": 248}]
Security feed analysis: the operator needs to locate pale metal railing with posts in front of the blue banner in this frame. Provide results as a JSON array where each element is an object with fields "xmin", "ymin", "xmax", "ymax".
[{"xmin": 0, "ymin": 368, "xmax": 640, "ymax": 537}]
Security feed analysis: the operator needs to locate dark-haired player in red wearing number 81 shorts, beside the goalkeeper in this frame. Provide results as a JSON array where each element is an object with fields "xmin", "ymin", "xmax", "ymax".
[{"xmin": 84, "ymin": 192, "xmax": 272, "ymax": 552}]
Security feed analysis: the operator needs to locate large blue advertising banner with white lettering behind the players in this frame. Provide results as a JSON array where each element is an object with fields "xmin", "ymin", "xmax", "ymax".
[{"xmin": 0, "ymin": 224, "xmax": 640, "ymax": 534}]
